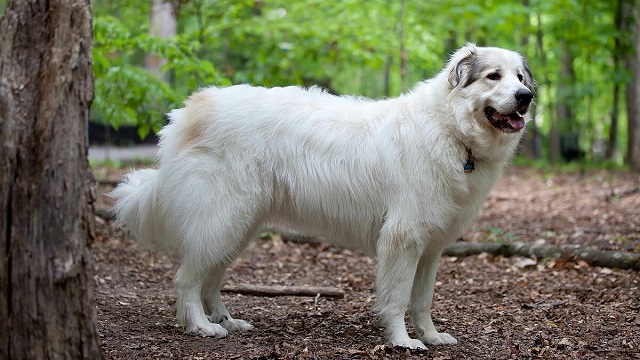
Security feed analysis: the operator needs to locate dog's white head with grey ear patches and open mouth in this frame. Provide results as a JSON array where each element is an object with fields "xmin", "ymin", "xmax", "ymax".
[{"xmin": 448, "ymin": 44, "xmax": 534, "ymax": 133}]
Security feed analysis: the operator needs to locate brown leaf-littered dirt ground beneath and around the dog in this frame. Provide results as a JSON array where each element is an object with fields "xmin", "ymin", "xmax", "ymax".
[{"xmin": 93, "ymin": 168, "xmax": 640, "ymax": 359}]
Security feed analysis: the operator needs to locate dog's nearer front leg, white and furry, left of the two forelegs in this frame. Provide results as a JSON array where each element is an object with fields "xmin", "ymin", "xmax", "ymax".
[{"xmin": 376, "ymin": 236, "xmax": 426, "ymax": 349}]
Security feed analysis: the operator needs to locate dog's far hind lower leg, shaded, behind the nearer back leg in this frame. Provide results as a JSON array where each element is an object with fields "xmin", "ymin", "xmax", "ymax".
[{"xmin": 202, "ymin": 263, "xmax": 253, "ymax": 331}]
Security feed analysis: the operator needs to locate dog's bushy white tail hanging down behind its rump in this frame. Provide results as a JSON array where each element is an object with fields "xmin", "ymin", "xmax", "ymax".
[{"xmin": 107, "ymin": 169, "xmax": 171, "ymax": 248}]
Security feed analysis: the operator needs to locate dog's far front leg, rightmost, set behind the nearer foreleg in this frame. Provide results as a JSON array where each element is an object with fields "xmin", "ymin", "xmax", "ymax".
[{"xmin": 410, "ymin": 249, "xmax": 458, "ymax": 345}]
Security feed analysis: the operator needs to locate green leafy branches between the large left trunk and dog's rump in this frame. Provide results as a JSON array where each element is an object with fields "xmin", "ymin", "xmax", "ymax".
[{"xmin": 93, "ymin": 2, "xmax": 228, "ymax": 138}]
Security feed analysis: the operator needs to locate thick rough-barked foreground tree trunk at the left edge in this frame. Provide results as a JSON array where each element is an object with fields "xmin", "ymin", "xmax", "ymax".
[{"xmin": 0, "ymin": 0, "xmax": 102, "ymax": 359}]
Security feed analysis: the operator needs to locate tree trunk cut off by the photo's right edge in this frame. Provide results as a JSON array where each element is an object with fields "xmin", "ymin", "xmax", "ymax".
[{"xmin": 627, "ymin": 2, "xmax": 640, "ymax": 171}]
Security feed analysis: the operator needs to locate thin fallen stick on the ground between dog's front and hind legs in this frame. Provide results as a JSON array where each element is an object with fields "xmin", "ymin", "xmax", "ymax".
[{"xmin": 220, "ymin": 284, "xmax": 344, "ymax": 298}]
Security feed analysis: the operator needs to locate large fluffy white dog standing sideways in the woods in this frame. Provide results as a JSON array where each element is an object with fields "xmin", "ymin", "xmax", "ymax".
[{"xmin": 111, "ymin": 44, "xmax": 533, "ymax": 348}]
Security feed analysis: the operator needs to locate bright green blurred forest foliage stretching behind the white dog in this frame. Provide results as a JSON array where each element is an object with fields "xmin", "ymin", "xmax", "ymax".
[{"xmin": 94, "ymin": 0, "xmax": 633, "ymax": 163}]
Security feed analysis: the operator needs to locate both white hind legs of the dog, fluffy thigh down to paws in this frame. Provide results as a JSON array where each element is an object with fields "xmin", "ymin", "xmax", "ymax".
[{"xmin": 172, "ymin": 165, "xmax": 270, "ymax": 337}]
